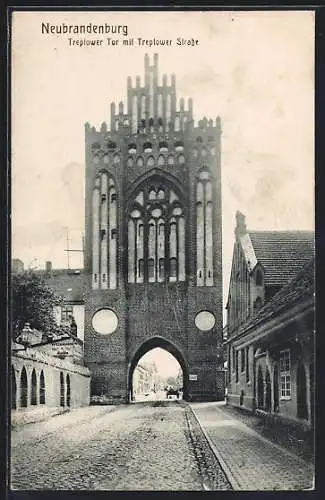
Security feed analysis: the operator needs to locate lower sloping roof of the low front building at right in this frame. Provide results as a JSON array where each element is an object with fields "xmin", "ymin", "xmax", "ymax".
[{"xmin": 238, "ymin": 257, "xmax": 315, "ymax": 335}]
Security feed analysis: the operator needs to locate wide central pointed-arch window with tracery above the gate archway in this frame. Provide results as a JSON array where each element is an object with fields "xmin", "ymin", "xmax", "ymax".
[{"xmin": 127, "ymin": 175, "xmax": 186, "ymax": 283}]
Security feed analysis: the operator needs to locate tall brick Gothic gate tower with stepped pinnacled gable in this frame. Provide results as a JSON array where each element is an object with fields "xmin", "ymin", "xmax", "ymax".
[{"xmin": 85, "ymin": 54, "xmax": 224, "ymax": 402}]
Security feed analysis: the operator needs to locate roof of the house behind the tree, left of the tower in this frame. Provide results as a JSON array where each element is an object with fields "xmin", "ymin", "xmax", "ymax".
[{"xmin": 43, "ymin": 269, "xmax": 84, "ymax": 303}]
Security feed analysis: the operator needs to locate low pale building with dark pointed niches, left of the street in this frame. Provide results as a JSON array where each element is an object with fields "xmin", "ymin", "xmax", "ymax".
[{"xmin": 11, "ymin": 335, "xmax": 90, "ymax": 426}]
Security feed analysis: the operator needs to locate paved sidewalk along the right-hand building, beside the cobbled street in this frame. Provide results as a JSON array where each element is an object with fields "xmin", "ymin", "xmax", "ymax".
[{"xmin": 190, "ymin": 402, "xmax": 314, "ymax": 491}]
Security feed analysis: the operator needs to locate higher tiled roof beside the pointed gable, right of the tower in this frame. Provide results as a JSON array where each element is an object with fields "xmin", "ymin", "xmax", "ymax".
[{"xmin": 248, "ymin": 231, "xmax": 315, "ymax": 286}]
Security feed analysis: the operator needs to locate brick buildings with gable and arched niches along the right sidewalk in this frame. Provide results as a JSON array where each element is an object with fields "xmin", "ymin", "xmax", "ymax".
[{"xmin": 225, "ymin": 213, "xmax": 315, "ymax": 427}]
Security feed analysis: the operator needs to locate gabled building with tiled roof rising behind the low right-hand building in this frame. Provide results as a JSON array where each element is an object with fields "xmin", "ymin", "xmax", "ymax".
[{"xmin": 226, "ymin": 212, "xmax": 314, "ymax": 336}]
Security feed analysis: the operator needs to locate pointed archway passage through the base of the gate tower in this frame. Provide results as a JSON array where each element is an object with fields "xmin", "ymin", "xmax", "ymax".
[{"xmin": 128, "ymin": 337, "xmax": 188, "ymax": 402}]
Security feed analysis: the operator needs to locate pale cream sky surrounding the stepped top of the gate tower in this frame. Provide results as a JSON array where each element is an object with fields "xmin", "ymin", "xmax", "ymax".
[{"xmin": 11, "ymin": 11, "xmax": 314, "ymax": 372}]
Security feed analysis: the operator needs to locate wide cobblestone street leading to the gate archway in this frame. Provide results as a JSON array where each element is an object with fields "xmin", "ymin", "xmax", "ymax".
[{"xmin": 11, "ymin": 402, "xmax": 230, "ymax": 490}]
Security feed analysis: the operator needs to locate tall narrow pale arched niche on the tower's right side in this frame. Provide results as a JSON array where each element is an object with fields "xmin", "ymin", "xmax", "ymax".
[{"xmin": 196, "ymin": 167, "xmax": 214, "ymax": 286}]
